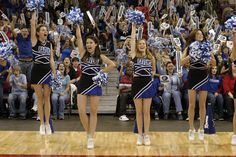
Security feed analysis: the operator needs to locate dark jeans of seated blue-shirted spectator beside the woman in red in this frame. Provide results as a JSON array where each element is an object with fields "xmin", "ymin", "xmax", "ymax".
[{"xmin": 207, "ymin": 92, "xmax": 224, "ymax": 118}]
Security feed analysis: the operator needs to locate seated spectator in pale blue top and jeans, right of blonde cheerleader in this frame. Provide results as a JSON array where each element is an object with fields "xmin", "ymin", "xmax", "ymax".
[{"xmin": 162, "ymin": 62, "xmax": 183, "ymax": 120}]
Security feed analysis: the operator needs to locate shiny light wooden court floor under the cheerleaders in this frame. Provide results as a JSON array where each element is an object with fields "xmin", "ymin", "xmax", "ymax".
[{"xmin": 0, "ymin": 131, "xmax": 236, "ymax": 157}]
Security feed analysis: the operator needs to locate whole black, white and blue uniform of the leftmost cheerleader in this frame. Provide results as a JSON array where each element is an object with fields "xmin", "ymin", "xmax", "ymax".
[{"xmin": 31, "ymin": 40, "xmax": 51, "ymax": 85}]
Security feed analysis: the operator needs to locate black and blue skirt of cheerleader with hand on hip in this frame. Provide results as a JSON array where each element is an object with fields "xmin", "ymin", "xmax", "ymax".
[{"xmin": 77, "ymin": 74, "xmax": 102, "ymax": 96}]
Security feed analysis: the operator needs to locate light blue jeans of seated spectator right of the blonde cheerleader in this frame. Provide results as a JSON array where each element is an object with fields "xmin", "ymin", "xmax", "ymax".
[{"xmin": 162, "ymin": 91, "xmax": 183, "ymax": 113}]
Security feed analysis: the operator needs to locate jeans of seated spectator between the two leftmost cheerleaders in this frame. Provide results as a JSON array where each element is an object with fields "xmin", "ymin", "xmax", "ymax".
[{"xmin": 51, "ymin": 93, "xmax": 69, "ymax": 118}]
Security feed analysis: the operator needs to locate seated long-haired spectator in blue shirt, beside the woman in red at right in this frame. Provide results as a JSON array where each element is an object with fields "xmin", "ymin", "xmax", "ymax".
[{"xmin": 207, "ymin": 66, "xmax": 224, "ymax": 120}]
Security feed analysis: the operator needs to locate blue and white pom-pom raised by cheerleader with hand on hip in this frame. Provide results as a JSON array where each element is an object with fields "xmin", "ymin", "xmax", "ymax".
[{"xmin": 66, "ymin": 7, "xmax": 84, "ymax": 24}]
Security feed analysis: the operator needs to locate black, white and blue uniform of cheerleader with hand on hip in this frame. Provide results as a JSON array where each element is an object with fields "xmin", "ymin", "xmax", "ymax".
[{"xmin": 78, "ymin": 57, "xmax": 102, "ymax": 96}]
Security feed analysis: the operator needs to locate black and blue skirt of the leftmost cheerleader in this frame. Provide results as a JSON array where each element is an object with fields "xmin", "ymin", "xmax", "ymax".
[{"xmin": 31, "ymin": 64, "xmax": 52, "ymax": 85}]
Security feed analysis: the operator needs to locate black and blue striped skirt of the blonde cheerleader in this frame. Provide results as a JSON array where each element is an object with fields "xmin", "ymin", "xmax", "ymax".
[{"xmin": 131, "ymin": 77, "xmax": 155, "ymax": 99}]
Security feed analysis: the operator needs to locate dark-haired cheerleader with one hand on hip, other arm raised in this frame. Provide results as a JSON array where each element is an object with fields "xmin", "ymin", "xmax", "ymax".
[{"xmin": 76, "ymin": 26, "xmax": 115, "ymax": 149}]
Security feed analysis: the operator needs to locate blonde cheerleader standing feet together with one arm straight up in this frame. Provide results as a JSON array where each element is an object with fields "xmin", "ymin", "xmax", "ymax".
[{"xmin": 130, "ymin": 24, "xmax": 156, "ymax": 145}]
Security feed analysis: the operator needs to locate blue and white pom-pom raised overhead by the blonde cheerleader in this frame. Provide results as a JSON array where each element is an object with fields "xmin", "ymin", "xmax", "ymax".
[{"xmin": 125, "ymin": 10, "xmax": 145, "ymax": 25}]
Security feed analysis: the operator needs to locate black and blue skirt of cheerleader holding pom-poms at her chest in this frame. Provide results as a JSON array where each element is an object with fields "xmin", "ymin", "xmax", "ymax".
[{"xmin": 188, "ymin": 68, "xmax": 209, "ymax": 91}]
